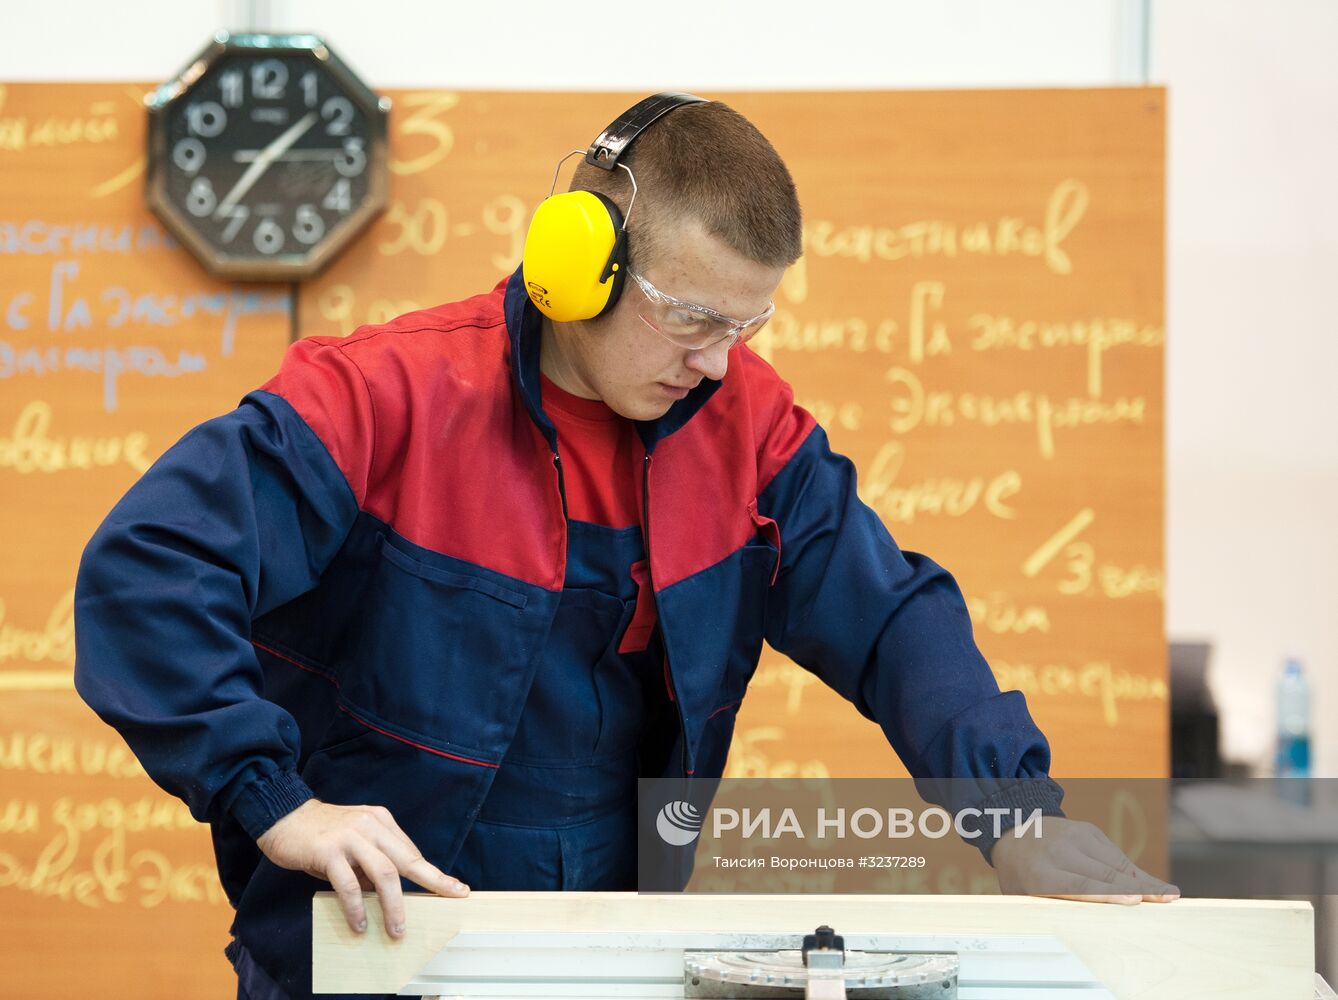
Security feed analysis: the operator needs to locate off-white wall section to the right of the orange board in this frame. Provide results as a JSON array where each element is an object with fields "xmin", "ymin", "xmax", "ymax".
[{"xmin": 1151, "ymin": 0, "xmax": 1338, "ymax": 776}]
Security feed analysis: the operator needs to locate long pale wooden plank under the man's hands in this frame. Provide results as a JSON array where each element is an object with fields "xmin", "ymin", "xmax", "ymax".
[{"xmin": 312, "ymin": 893, "xmax": 1314, "ymax": 1000}]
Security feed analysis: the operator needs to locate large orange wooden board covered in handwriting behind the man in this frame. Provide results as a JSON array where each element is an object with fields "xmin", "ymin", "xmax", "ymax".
[{"xmin": 0, "ymin": 84, "xmax": 1167, "ymax": 997}]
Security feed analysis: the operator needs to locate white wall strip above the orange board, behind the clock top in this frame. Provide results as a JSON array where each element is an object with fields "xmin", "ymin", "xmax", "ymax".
[{"xmin": 0, "ymin": 0, "xmax": 1140, "ymax": 91}]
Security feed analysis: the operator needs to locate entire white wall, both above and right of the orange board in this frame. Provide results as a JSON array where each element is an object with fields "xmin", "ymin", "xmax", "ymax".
[{"xmin": 0, "ymin": 0, "xmax": 1338, "ymax": 775}]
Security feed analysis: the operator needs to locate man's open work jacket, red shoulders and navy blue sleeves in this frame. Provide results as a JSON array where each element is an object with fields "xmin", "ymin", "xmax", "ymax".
[{"xmin": 75, "ymin": 274, "xmax": 1060, "ymax": 1000}]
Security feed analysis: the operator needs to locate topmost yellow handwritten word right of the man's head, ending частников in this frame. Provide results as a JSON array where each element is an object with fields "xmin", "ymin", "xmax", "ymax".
[{"xmin": 804, "ymin": 179, "xmax": 1090, "ymax": 274}]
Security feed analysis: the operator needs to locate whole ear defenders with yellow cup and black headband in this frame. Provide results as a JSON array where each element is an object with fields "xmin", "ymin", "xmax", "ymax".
[{"xmin": 522, "ymin": 92, "xmax": 705, "ymax": 323}]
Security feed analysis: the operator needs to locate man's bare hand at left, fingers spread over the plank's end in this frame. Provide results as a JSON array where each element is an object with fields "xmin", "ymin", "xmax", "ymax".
[{"xmin": 256, "ymin": 799, "xmax": 470, "ymax": 937}]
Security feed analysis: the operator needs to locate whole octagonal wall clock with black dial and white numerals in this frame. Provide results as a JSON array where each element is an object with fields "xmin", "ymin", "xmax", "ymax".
[{"xmin": 149, "ymin": 36, "xmax": 385, "ymax": 278}]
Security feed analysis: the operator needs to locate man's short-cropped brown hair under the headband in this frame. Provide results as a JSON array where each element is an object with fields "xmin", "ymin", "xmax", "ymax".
[{"xmin": 571, "ymin": 100, "xmax": 803, "ymax": 269}]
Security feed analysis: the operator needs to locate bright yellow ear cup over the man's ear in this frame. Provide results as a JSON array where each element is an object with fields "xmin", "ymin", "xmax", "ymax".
[{"xmin": 522, "ymin": 191, "xmax": 628, "ymax": 323}]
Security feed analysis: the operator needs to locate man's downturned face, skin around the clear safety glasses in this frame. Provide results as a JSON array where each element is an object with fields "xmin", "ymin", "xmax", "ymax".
[{"xmin": 543, "ymin": 220, "xmax": 785, "ymax": 420}]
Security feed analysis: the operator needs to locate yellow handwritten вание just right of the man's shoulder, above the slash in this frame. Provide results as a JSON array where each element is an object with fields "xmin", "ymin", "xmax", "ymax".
[{"xmin": 859, "ymin": 440, "xmax": 1022, "ymax": 525}]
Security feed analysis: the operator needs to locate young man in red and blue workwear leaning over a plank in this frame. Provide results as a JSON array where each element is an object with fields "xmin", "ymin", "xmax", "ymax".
[{"xmin": 76, "ymin": 95, "xmax": 1172, "ymax": 1000}]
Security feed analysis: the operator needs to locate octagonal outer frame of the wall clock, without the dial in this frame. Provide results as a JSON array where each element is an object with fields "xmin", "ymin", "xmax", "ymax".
[{"xmin": 145, "ymin": 31, "xmax": 391, "ymax": 281}]
